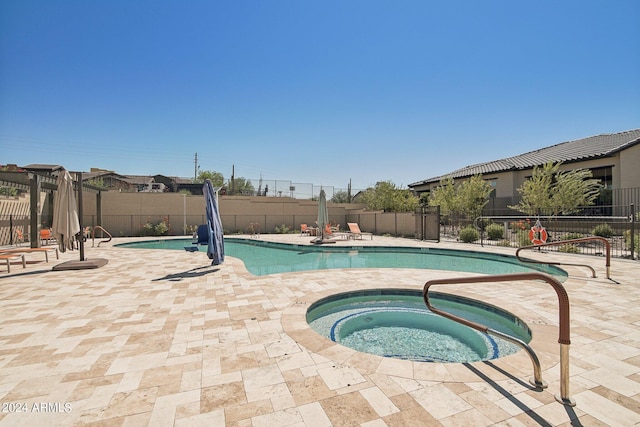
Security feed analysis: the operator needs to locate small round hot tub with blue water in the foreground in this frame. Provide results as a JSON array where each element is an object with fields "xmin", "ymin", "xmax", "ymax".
[{"xmin": 307, "ymin": 289, "xmax": 531, "ymax": 363}]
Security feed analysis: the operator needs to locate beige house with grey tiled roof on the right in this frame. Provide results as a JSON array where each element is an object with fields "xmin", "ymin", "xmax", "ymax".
[{"xmin": 409, "ymin": 129, "xmax": 640, "ymax": 204}]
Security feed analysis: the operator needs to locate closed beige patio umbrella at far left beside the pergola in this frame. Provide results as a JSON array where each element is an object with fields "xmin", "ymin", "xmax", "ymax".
[{"xmin": 52, "ymin": 170, "xmax": 80, "ymax": 252}]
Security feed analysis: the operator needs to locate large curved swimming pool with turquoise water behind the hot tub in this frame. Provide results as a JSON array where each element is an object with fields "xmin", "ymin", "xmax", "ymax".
[{"xmin": 116, "ymin": 238, "xmax": 567, "ymax": 281}]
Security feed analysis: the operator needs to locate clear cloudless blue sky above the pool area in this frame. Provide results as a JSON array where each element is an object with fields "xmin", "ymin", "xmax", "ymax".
[{"xmin": 0, "ymin": 0, "xmax": 640, "ymax": 195}]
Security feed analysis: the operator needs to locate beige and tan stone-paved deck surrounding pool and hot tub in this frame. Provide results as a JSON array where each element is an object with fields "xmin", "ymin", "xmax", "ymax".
[{"xmin": 0, "ymin": 234, "xmax": 640, "ymax": 427}]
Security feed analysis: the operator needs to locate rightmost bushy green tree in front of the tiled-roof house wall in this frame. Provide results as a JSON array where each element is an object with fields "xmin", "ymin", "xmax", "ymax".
[{"xmin": 509, "ymin": 162, "xmax": 600, "ymax": 216}]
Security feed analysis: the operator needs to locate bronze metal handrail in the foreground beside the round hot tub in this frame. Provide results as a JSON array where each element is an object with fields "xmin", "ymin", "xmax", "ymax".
[{"xmin": 423, "ymin": 272, "xmax": 576, "ymax": 406}]
